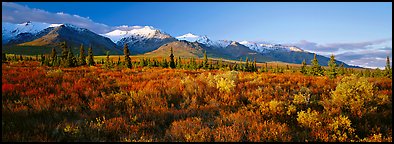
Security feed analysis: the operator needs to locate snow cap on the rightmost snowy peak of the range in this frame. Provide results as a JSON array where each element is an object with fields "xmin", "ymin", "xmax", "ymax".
[{"xmin": 239, "ymin": 41, "xmax": 304, "ymax": 53}]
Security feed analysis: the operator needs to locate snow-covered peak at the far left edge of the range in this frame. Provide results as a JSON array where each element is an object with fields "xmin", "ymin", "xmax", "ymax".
[{"xmin": 1, "ymin": 21, "xmax": 62, "ymax": 44}]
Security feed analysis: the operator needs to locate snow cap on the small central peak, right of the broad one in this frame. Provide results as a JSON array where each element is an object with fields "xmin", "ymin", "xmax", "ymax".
[{"xmin": 176, "ymin": 33, "xmax": 233, "ymax": 48}]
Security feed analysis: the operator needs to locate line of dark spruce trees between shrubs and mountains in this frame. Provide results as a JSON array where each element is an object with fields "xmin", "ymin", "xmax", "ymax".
[{"xmin": 2, "ymin": 42, "xmax": 392, "ymax": 78}]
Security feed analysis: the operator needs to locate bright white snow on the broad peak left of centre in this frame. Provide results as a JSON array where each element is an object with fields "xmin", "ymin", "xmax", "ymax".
[{"xmin": 101, "ymin": 26, "xmax": 171, "ymax": 43}]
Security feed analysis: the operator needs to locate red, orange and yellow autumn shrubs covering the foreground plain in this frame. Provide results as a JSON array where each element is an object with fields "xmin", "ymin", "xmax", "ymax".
[{"xmin": 2, "ymin": 58, "xmax": 392, "ymax": 142}]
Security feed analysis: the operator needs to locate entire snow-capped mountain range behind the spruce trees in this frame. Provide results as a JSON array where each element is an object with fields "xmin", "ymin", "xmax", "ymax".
[{"xmin": 2, "ymin": 21, "xmax": 356, "ymax": 67}]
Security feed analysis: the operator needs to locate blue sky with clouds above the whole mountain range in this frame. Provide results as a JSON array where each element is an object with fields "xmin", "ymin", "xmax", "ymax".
[{"xmin": 2, "ymin": 2, "xmax": 392, "ymax": 68}]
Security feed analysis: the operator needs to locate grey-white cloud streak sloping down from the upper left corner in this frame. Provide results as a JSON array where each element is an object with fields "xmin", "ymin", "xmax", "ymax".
[{"xmin": 2, "ymin": 2, "xmax": 113, "ymax": 34}]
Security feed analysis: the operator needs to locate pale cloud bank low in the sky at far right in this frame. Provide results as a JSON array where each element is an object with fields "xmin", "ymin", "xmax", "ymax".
[{"xmin": 291, "ymin": 38, "xmax": 392, "ymax": 68}]
